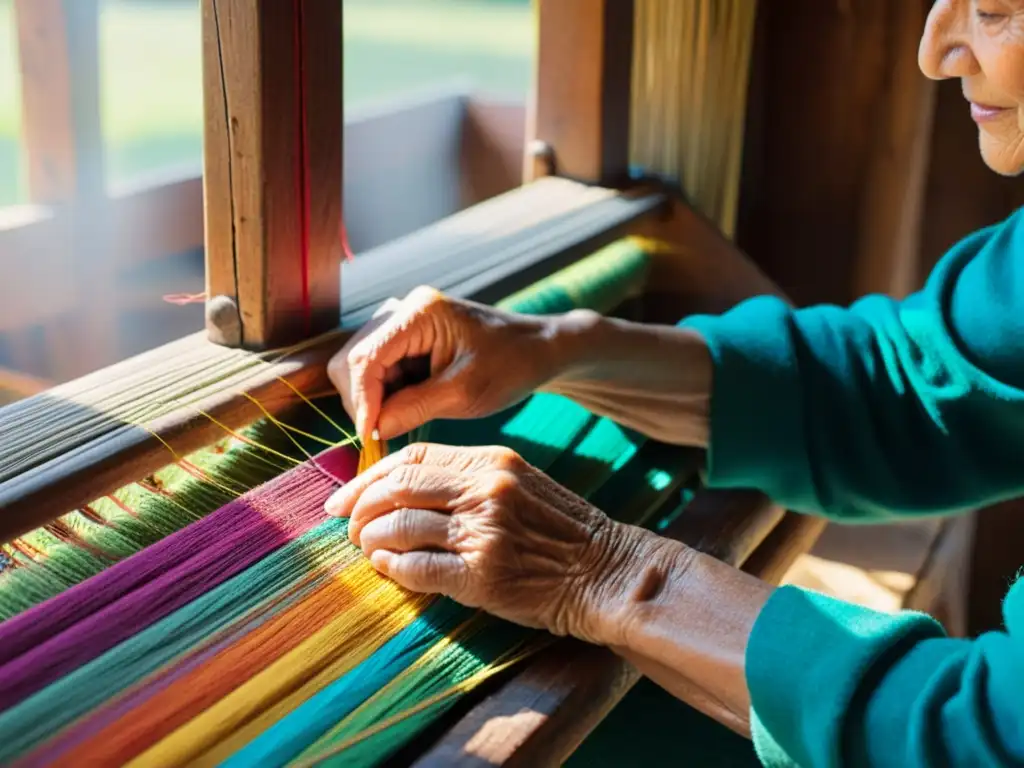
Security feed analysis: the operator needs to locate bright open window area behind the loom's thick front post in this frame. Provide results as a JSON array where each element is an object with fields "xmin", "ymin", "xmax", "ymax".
[{"xmin": 0, "ymin": 0, "xmax": 535, "ymax": 382}]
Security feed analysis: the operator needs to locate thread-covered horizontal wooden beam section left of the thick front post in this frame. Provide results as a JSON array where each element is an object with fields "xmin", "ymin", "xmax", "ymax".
[{"xmin": 0, "ymin": 334, "xmax": 341, "ymax": 542}]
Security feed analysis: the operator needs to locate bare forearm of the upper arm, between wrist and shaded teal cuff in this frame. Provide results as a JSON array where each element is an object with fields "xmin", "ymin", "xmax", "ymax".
[{"xmin": 543, "ymin": 311, "xmax": 712, "ymax": 447}]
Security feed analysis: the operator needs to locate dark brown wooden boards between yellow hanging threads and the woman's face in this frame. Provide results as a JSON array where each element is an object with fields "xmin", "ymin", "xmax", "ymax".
[{"xmin": 737, "ymin": 0, "xmax": 934, "ymax": 304}]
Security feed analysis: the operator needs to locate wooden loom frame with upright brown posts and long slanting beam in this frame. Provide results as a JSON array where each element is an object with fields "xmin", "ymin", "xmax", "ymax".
[{"xmin": 0, "ymin": 0, "xmax": 999, "ymax": 765}]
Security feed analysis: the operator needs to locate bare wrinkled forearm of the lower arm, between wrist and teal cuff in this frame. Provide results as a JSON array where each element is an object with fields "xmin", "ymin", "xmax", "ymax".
[{"xmin": 587, "ymin": 526, "xmax": 772, "ymax": 733}]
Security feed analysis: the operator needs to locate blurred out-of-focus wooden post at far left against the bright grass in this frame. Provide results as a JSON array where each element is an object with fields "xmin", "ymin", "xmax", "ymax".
[{"xmin": 14, "ymin": 0, "xmax": 118, "ymax": 381}]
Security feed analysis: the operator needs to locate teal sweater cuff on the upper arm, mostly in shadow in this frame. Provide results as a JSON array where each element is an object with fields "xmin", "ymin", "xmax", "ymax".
[{"xmin": 680, "ymin": 297, "xmax": 815, "ymax": 510}]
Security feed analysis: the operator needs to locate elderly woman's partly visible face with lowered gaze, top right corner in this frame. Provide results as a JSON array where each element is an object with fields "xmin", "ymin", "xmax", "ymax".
[{"xmin": 921, "ymin": 0, "xmax": 1024, "ymax": 176}]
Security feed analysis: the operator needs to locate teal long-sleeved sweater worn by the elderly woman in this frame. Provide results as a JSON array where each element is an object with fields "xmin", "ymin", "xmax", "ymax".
[{"xmin": 687, "ymin": 209, "xmax": 1024, "ymax": 768}]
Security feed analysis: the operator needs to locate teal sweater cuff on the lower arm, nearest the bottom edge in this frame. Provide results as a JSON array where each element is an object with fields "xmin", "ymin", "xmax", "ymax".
[{"xmin": 745, "ymin": 587, "xmax": 944, "ymax": 766}]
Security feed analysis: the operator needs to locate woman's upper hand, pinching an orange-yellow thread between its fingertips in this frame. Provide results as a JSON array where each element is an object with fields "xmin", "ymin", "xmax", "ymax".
[{"xmin": 328, "ymin": 288, "xmax": 557, "ymax": 439}]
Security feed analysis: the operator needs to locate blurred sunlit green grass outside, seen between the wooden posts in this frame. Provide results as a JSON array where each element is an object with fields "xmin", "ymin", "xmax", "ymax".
[{"xmin": 0, "ymin": 0, "xmax": 535, "ymax": 206}]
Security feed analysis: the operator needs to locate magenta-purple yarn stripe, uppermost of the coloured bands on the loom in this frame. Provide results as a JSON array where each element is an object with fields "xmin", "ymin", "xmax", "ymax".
[{"xmin": 0, "ymin": 446, "xmax": 358, "ymax": 711}]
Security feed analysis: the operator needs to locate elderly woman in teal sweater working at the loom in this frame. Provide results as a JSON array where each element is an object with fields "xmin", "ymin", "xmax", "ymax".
[{"xmin": 329, "ymin": 0, "xmax": 1024, "ymax": 768}]
